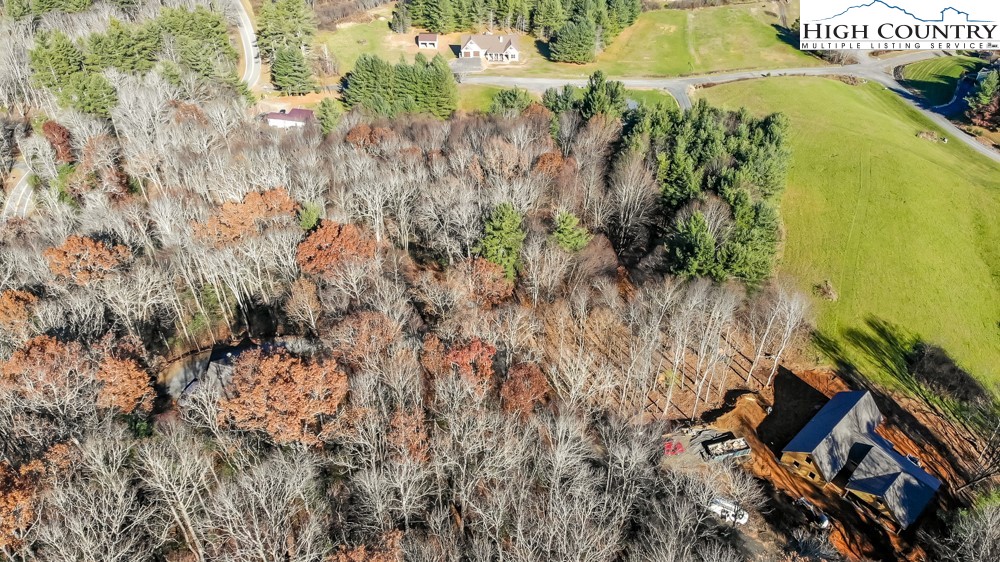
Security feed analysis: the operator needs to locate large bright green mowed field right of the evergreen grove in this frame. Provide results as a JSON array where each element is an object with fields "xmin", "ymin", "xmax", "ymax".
[{"xmin": 700, "ymin": 74, "xmax": 1000, "ymax": 388}]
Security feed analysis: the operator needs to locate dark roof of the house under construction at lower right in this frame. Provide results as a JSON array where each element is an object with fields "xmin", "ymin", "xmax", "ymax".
[{"xmin": 784, "ymin": 391, "xmax": 941, "ymax": 528}]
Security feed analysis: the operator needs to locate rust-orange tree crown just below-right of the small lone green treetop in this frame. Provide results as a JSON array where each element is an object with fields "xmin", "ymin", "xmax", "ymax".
[{"xmin": 295, "ymin": 221, "xmax": 375, "ymax": 275}]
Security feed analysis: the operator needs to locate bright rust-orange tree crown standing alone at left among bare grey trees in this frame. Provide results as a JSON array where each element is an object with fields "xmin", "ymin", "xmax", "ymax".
[{"xmin": 42, "ymin": 235, "xmax": 132, "ymax": 285}]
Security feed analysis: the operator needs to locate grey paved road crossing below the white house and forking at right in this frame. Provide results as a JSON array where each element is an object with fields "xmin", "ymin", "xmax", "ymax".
[{"xmin": 462, "ymin": 51, "xmax": 1000, "ymax": 162}]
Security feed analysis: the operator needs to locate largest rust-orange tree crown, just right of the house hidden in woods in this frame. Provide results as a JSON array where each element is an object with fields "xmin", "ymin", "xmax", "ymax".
[{"xmin": 219, "ymin": 349, "xmax": 347, "ymax": 446}]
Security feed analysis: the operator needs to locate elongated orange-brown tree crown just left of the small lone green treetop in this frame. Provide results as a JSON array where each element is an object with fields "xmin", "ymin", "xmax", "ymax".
[{"xmin": 192, "ymin": 188, "xmax": 299, "ymax": 248}]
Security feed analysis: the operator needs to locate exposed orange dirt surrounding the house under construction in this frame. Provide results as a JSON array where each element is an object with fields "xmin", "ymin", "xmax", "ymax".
[{"xmin": 715, "ymin": 369, "xmax": 989, "ymax": 561}]
